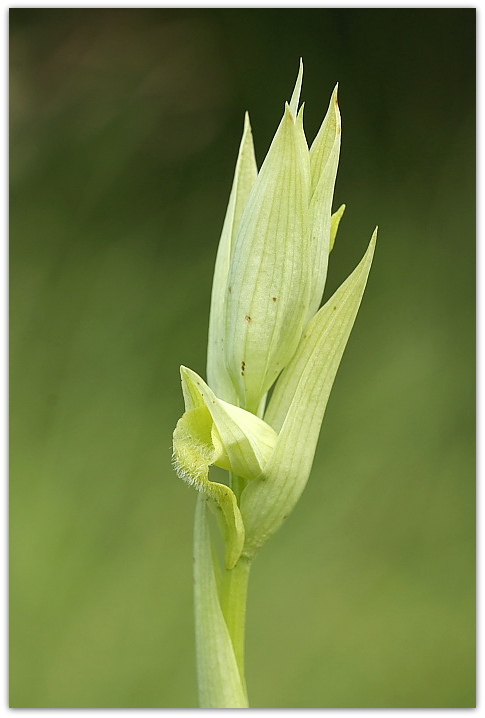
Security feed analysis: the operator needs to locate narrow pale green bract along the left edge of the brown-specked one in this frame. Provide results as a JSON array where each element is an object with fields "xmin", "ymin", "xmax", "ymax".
[{"xmin": 207, "ymin": 113, "xmax": 258, "ymax": 404}]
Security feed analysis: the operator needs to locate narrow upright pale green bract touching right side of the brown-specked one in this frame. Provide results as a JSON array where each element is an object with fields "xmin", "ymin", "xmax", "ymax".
[{"xmin": 308, "ymin": 87, "xmax": 341, "ymax": 319}]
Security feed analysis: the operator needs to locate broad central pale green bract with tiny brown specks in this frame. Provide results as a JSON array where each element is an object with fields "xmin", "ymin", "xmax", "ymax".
[{"xmin": 225, "ymin": 105, "xmax": 311, "ymax": 413}]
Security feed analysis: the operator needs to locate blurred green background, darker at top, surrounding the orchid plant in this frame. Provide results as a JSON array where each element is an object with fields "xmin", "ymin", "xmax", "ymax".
[{"xmin": 10, "ymin": 8, "xmax": 475, "ymax": 708}]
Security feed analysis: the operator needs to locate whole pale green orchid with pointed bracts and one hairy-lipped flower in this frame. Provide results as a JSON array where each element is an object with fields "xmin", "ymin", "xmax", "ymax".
[{"xmin": 173, "ymin": 61, "xmax": 377, "ymax": 708}]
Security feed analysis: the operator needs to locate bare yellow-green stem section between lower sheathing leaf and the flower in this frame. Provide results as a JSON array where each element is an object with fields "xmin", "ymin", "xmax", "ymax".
[{"xmin": 221, "ymin": 556, "xmax": 251, "ymax": 690}]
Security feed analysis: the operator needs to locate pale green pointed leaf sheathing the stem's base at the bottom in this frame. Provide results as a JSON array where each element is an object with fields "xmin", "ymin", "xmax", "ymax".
[{"xmin": 194, "ymin": 495, "xmax": 248, "ymax": 708}]
